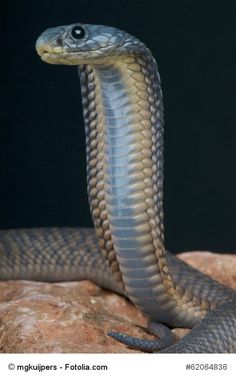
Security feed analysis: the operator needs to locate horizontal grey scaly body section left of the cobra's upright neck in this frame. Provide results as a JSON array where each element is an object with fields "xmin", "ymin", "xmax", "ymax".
[{"xmin": 0, "ymin": 228, "xmax": 123, "ymax": 293}]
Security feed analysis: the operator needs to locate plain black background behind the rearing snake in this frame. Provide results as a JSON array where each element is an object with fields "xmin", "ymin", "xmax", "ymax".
[{"xmin": 0, "ymin": 0, "xmax": 236, "ymax": 252}]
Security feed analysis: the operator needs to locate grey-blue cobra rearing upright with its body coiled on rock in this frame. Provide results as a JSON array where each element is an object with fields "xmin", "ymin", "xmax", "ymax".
[{"xmin": 0, "ymin": 23, "xmax": 236, "ymax": 353}]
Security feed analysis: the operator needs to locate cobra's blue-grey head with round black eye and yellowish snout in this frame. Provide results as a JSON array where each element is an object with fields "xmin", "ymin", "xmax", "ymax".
[{"xmin": 36, "ymin": 23, "xmax": 149, "ymax": 65}]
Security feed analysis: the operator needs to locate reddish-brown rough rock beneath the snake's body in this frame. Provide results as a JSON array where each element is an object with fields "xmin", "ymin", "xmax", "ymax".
[{"xmin": 0, "ymin": 252, "xmax": 236, "ymax": 353}]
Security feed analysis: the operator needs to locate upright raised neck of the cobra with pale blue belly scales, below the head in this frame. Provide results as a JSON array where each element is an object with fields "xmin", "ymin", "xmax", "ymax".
[{"xmin": 79, "ymin": 53, "xmax": 208, "ymax": 325}]
